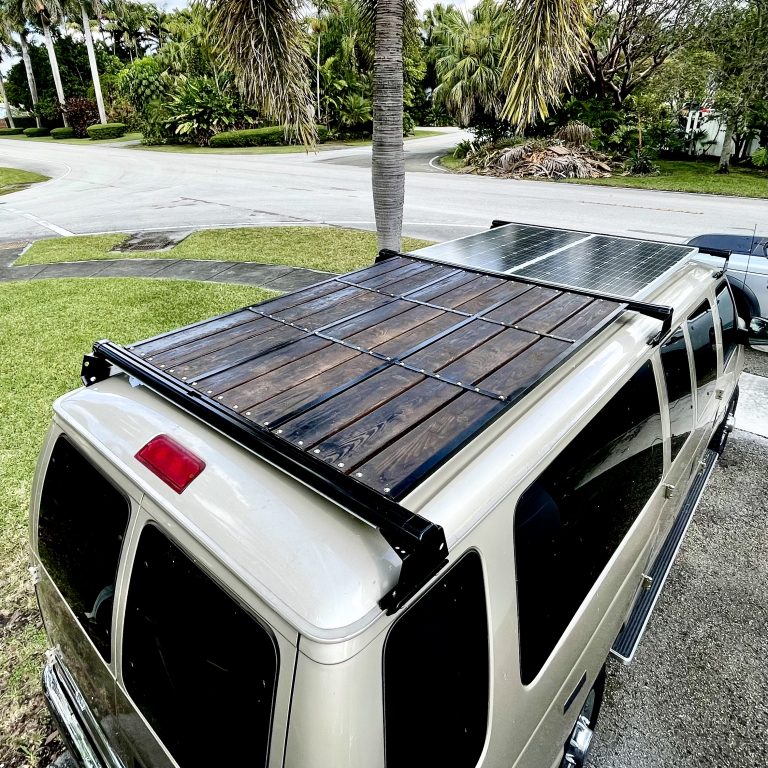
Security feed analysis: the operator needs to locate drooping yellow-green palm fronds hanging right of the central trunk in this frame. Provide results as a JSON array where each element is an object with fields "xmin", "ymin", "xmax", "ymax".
[{"xmin": 502, "ymin": 0, "xmax": 591, "ymax": 128}]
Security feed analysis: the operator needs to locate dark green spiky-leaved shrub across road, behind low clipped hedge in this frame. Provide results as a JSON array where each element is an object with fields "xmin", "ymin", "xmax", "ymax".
[{"xmin": 165, "ymin": 77, "xmax": 253, "ymax": 147}]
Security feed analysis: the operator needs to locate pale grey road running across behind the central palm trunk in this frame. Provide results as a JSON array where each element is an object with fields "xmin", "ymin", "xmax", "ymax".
[{"xmin": 0, "ymin": 131, "xmax": 768, "ymax": 241}]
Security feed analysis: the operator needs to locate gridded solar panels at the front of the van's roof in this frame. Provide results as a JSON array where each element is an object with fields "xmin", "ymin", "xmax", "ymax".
[{"xmin": 413, "ymin": 224, "xmax": 694, "ymax": 297}]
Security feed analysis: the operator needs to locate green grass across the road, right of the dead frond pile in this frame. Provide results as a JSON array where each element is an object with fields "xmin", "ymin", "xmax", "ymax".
[{"xmin": 565, "ymin": 160, "xmax": 768, "ymax": 198}]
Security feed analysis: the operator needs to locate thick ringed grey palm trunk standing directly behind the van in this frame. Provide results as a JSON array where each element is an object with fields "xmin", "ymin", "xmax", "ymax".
[{"xmin": 371, "ymin": 0, "xmax": 405, "ymax": 251}]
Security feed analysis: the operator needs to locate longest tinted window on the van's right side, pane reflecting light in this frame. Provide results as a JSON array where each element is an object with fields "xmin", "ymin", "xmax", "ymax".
[{"xmin": 515, "ymin": 362, "xmax": 664, "ymax": 684}]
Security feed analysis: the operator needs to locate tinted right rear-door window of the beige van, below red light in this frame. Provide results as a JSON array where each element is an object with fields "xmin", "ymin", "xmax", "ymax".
[{"xmin": 123, "ymin": 526, "xmax": 278, "ymax": 768}]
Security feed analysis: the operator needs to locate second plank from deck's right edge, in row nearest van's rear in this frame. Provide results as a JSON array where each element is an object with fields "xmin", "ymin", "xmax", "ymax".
[{"xmin": 312, "ymin": 379, "xmax": 462, "ymax": 472}]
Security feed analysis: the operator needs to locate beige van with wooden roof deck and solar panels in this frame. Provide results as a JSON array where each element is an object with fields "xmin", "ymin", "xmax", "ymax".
[{"xmin": 31, "ymin": 224, "xmax": 760, "ymax": 768}]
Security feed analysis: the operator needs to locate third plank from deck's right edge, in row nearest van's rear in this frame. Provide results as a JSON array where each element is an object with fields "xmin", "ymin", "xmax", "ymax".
[{"xmin": 282, "ymin": 366, "xmax": 424, "ymax": 448}]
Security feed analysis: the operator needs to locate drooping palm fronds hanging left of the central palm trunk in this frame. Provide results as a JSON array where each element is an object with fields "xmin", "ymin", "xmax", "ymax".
[{"xmin": 208, "ymin": 0, "xmax": 317, "ymax": 146}]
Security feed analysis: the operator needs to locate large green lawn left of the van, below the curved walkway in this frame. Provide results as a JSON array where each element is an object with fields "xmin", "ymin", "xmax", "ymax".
[{"xmin": 0, "ymin": 278, "xmax": 274, "ymax": 768}]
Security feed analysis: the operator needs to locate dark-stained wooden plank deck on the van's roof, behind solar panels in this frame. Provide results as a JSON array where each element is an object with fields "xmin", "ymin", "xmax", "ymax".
[{"xmin": 128, "ymin": 256, "xmax": 626, "ymax": 500}]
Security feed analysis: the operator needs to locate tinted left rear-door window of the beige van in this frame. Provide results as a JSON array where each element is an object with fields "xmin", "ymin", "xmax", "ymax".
[{"xmin": 37, "ymin": 437, "xmax": 131, "ymax": 662}]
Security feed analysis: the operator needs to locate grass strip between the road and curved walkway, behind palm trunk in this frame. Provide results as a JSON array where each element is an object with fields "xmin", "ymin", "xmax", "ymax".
[{"xmin": 16, "ymin": 227, "xmax": 431, "ymax": 272}]
